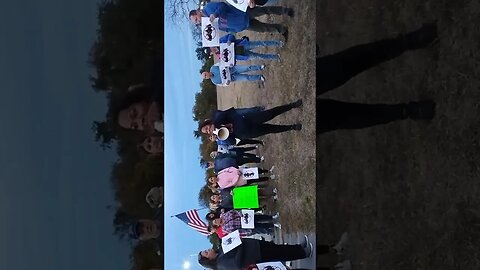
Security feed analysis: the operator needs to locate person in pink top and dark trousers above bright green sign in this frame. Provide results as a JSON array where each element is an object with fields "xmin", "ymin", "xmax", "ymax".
[{"xmin": 217, "ymin": 167, "xmax": 275, "ymax": 189}]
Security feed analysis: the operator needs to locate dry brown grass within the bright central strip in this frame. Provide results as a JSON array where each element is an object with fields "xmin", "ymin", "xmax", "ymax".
[{"xmin": 217, "ymin": 1, "xmax": 316, "ymax": 232}]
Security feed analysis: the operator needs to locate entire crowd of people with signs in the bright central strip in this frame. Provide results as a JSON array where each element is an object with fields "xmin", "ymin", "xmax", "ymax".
[{"xmin": 189, "ymin": 1, "xmax": 332, "ymax": 270}]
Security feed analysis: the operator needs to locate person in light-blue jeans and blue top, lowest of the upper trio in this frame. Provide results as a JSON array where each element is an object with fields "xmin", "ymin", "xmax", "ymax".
[{"xmin": 201, "ymin": 64, "xmax": 265, "ymax": 86}]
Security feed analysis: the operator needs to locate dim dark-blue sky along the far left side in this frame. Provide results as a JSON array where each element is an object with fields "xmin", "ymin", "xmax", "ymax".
[{"xmin": 0, "ymin": 0, "xmax": 130, "ymax": 270}]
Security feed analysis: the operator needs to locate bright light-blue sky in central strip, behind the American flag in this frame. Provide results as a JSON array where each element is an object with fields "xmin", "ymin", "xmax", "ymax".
[{"xmin": 164, "ymin": 2, "xmax": 211, "ymax": 269}]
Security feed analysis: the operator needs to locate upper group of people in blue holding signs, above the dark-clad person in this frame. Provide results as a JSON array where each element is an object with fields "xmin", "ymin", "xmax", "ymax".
[{"xmin": 189, "ymin": 1, "xmax": 294, "ymax": 86}]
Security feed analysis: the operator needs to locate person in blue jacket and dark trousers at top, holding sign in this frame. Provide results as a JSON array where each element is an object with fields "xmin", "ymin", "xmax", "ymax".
[{"xmin": 188, "ymin": 2, "xmax": 294, "ymax": 39}]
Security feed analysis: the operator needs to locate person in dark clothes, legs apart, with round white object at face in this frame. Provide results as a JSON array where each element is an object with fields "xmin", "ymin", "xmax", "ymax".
[{"xmin": 199, "ymin": 99, "xmax": 303, "ymax": 139}]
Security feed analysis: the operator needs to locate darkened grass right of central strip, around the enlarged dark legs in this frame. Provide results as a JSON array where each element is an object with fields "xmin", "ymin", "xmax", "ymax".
[{"xmin": 316, "ymin": 0, "xmax": 480, "ymax": 270}]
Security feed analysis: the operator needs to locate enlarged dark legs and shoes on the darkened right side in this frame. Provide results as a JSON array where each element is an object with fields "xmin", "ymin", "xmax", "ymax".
[{"xmin": 316, "ymin": 22, "xmax": 438, "ymax": 134}]
